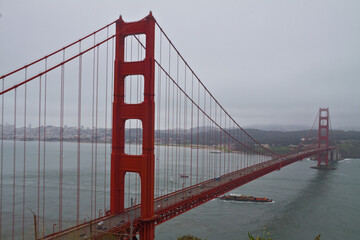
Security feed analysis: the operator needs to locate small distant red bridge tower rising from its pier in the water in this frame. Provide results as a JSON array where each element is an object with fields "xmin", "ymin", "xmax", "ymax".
[{"xmin": 317, "ymin": 108, "xmax": 329, "ymax": 167}]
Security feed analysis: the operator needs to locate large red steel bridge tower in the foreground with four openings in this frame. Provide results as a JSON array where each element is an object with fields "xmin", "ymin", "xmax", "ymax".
[{"xmin": 110, "ymin": 12, "xmax": 155, "ymax": 239}]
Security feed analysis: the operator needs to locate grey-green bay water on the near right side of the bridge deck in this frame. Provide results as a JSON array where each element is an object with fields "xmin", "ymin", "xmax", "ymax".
[{"xmin": 156, "ymin": 159, "xmax": 360, "ymax": 240}]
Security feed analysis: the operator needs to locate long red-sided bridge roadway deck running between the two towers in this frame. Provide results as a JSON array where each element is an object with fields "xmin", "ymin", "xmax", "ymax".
[{"xmin": 43, "ymin": 147, "xmax": 332, "ymax": 240}]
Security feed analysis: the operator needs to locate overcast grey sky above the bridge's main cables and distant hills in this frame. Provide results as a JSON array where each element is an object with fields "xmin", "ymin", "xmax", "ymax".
[{"xmin": 0, "ymin": 0, "xmax": 360, "ymax": 130}]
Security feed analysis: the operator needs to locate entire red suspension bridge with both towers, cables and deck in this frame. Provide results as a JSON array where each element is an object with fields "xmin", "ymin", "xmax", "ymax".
[{"xmin": 0, "ymin": 13, "xmax": 335, "ymax": 239}]
